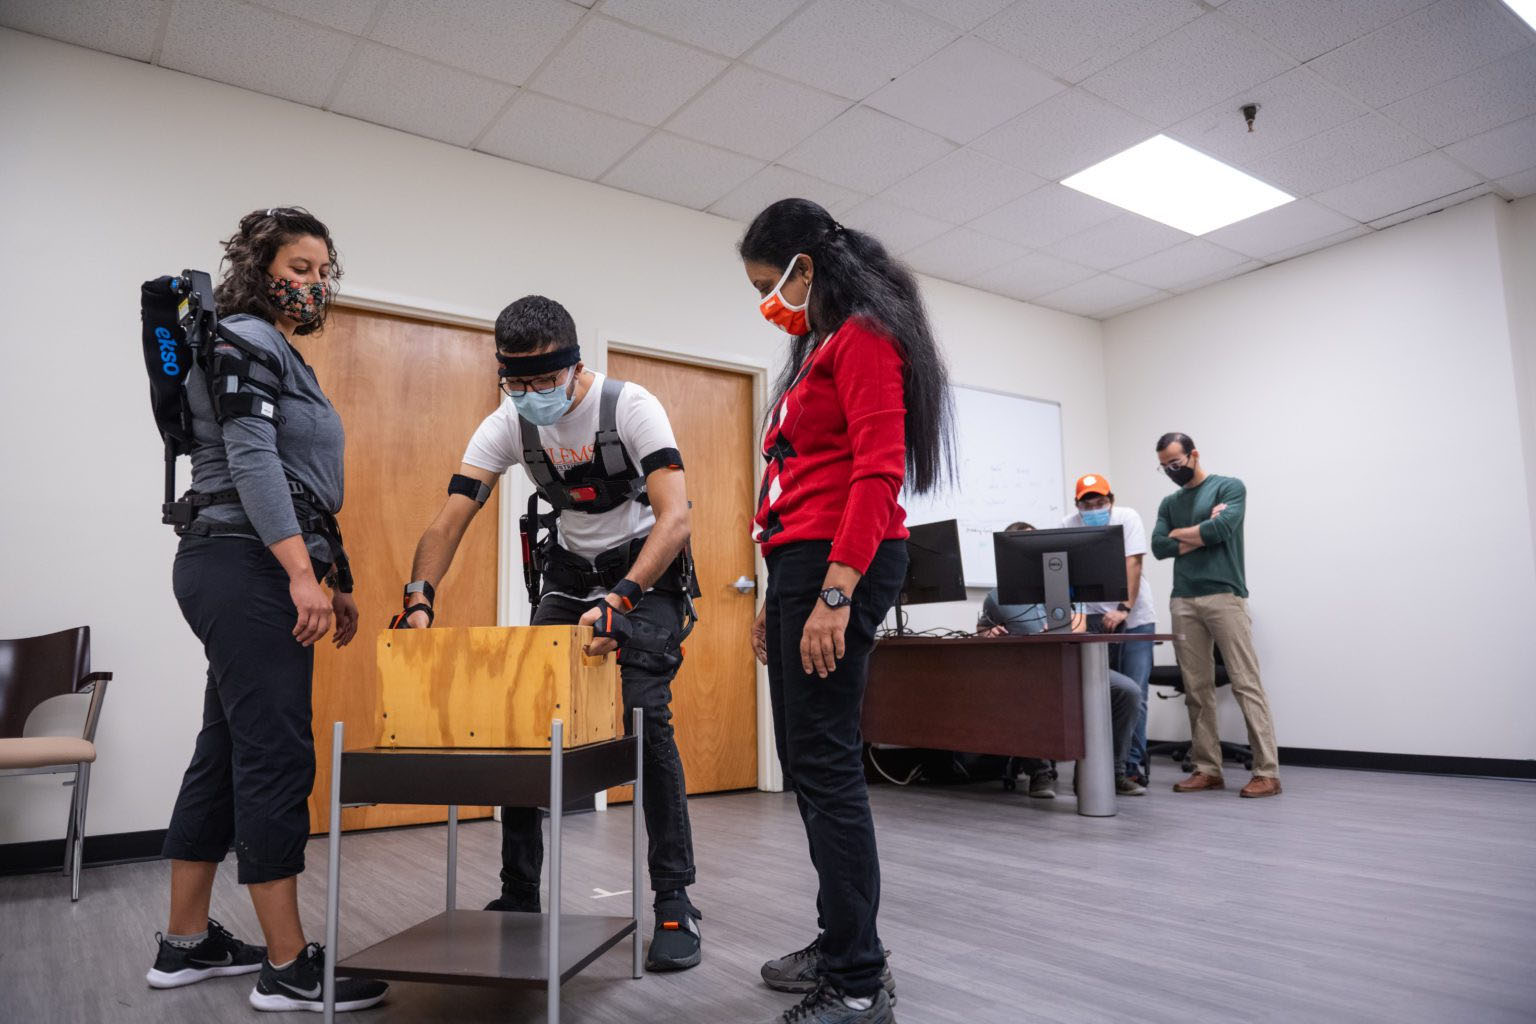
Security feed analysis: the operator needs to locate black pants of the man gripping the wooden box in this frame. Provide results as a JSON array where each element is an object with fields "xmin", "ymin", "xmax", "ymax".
[{"xmin": 501, "ymin": 590, "xmax": 694, "ymax": 910}]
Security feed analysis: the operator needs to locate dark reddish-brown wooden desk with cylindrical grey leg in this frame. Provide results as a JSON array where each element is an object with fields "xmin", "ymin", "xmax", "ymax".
[{"xmin": 863, "ymin": 633, "xmax": 1174, "ymax": 817}]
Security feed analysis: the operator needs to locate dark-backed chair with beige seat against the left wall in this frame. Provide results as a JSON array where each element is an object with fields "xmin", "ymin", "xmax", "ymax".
[{"xmin": 0, "ymin": 626, "xmax": 112, "ymax": 901}]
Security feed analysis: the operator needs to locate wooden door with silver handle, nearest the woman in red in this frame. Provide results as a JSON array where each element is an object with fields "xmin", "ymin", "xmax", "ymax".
[{"xmin": 608, "ymin": 352, "xmax": 757, "ymax": 800}]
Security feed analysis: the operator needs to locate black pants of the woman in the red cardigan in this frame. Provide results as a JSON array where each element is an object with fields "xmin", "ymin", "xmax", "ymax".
[{"xmin": 768, "ymin": 540, "xmax": 906, "ymax": 996}]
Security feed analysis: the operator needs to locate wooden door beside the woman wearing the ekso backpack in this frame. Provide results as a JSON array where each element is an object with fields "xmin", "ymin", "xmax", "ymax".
[{"xmin": 300, "ymin": 310, "xmax": 499, "ymax": 832}]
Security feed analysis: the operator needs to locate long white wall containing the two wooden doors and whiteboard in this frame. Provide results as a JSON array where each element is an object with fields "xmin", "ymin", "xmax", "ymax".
[{"xmin": 0, "ymin": 31, "xmax": 1109, "ymax": 843}]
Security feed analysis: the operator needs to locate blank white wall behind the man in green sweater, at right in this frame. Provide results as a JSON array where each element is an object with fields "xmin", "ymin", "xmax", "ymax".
[{"xmin": 1104, "ymin": 198, "xmax": 1536, "ymax": 758}]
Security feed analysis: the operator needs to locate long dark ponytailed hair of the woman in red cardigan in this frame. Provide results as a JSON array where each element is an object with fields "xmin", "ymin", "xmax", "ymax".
[{"xmin": 736, "ymin": 200, "xmax": 954, "ymax": 494}]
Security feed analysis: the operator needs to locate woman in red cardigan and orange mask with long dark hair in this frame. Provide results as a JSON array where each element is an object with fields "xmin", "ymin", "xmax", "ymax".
[{"xmin": 739, "ymin": 200, "xmax": 952, "ymax": 1024}]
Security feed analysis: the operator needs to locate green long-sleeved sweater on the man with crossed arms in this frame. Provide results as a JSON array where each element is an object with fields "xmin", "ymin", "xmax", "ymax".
[{"xmin": 1152, "ymin": 474, "xmax": 1247, "ymax": 597}]
